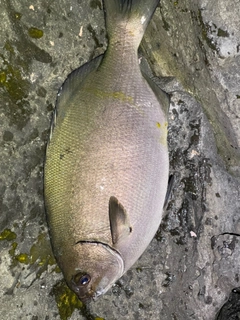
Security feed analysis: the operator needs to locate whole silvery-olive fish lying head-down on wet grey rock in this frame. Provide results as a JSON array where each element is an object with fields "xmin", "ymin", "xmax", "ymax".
[{"xmin": 44, "ymin": 0, "xmax": 169, "ymax": 303}]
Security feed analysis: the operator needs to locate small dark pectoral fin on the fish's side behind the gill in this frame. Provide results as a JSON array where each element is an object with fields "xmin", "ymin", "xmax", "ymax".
[{"xmin": 109, "ymin": 197, "xmax": 132, "ymax": 244}]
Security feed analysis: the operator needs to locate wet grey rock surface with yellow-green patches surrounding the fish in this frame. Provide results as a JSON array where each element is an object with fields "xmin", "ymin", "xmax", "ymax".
[{"xmin": 0, "ymin": 0, "xmax": 240, "ymax": 320}]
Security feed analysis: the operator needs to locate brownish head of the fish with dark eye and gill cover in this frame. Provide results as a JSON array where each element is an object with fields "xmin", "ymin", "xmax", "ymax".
[{"xmin": 59, "ymin": 242, "xmax": 124, "ymax": 303}]
